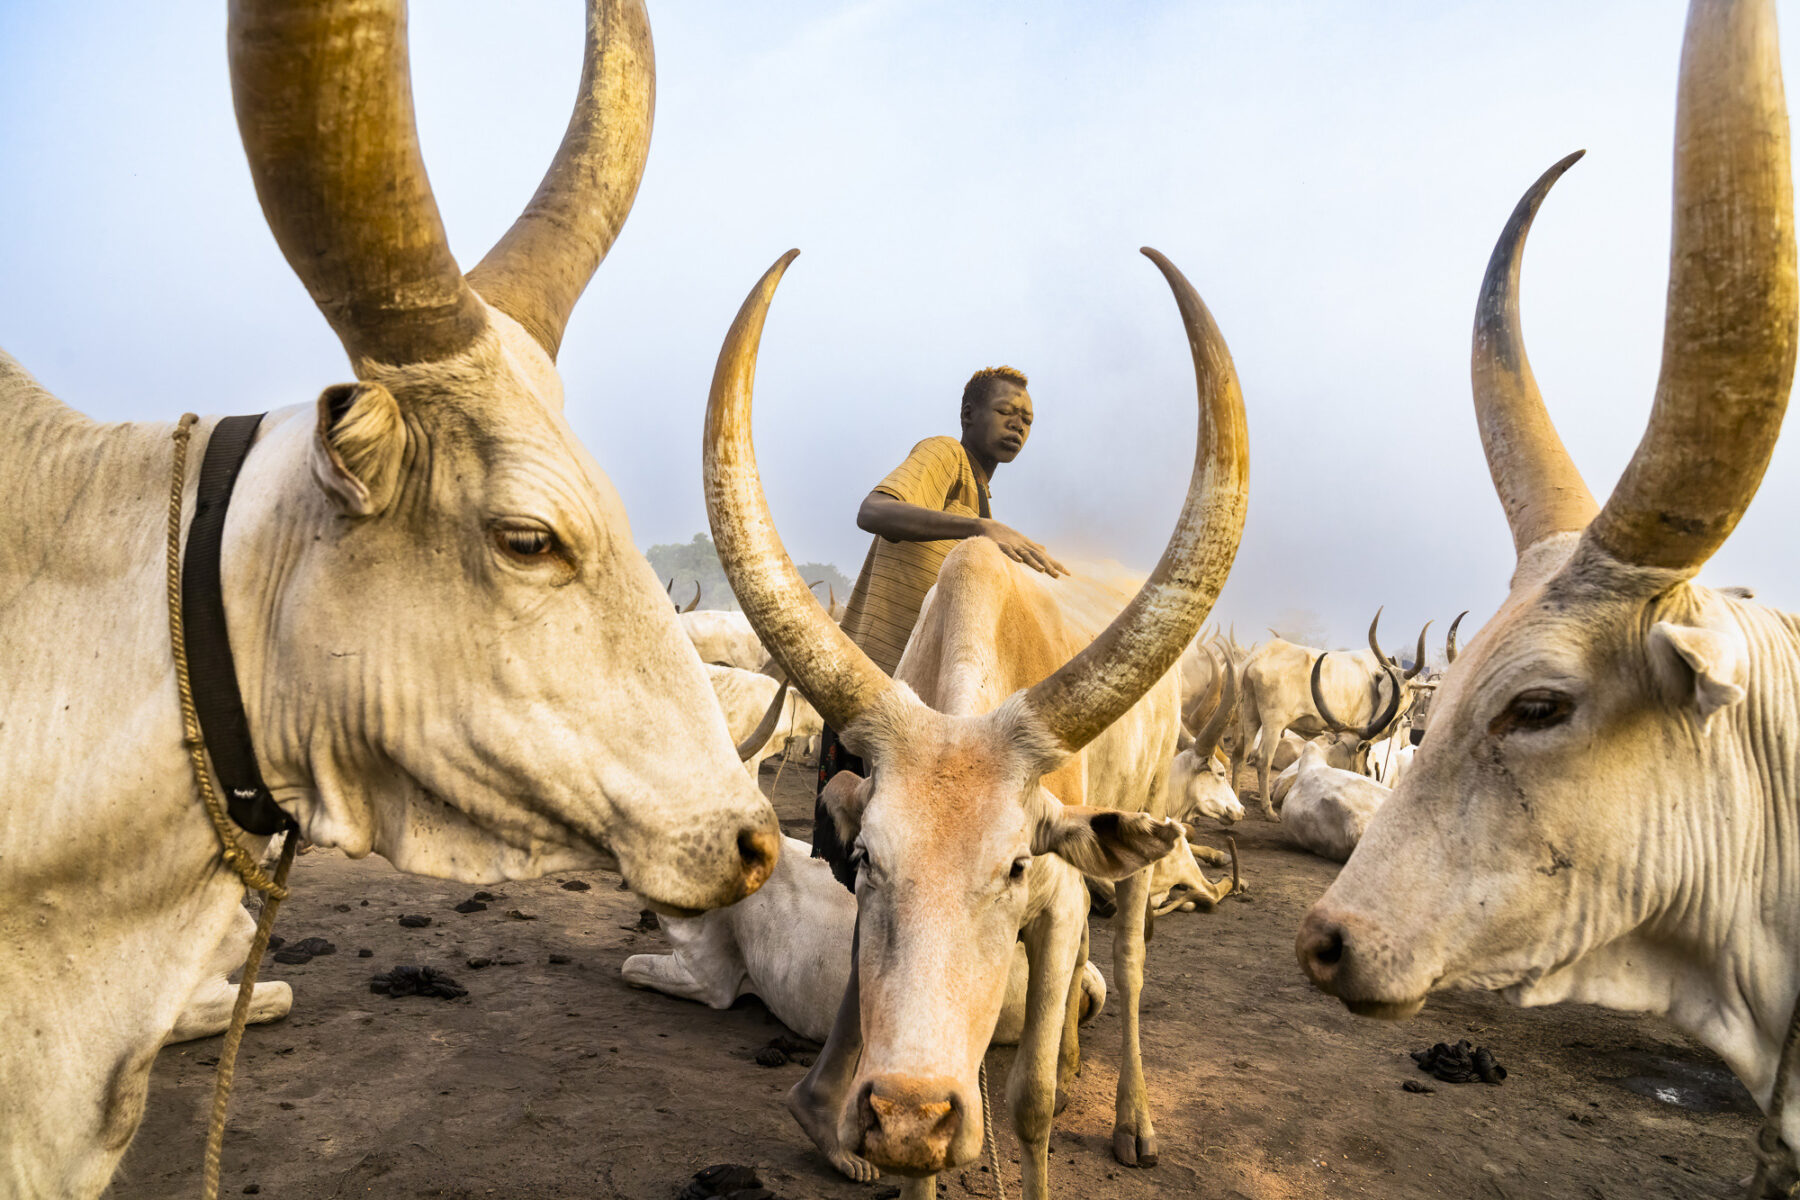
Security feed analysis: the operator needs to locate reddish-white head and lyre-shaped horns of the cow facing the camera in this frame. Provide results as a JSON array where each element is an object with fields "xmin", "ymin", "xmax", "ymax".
[{"xmin": 706, "ymin": 250, "xmax": 1247, "ymax": 1175}]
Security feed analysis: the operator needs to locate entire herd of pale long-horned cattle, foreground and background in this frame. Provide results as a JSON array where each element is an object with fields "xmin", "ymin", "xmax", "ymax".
[{"xmin": 0, "ymin": 0, "xmax": 1800, "ymax": 1196}]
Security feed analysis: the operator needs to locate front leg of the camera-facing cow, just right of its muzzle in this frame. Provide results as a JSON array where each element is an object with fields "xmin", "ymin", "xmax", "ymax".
[{"xmin": 1006, "ymin": 880, "xmax": 1087, "ymax": 1200}]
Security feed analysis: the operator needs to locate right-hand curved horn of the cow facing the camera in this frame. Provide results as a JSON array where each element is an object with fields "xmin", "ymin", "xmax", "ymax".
[{"xmin": 1026, "ymin": 246, "xmax": 1249, "ymax": 754}]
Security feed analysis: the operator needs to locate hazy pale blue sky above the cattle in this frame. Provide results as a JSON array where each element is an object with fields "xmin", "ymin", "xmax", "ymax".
[{"xmin": 0, "ymin": 0, "xmax": 1800, "ymax": 658}]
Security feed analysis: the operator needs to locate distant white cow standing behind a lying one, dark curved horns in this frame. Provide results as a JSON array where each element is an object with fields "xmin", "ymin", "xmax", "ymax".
[{"xmin": 1231, "ymin": 610, "xmax": 1431, "ymax": 820}]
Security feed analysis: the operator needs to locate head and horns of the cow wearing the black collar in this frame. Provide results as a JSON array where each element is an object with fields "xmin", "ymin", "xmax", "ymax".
[{"xmin": 225, "ymin": 0, "xmax": 779, "ymax": 909}]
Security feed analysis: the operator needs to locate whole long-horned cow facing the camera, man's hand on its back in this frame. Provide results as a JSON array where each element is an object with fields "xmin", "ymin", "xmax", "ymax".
[{"xmin": 706, "ymin": 250, "xmax": 1247, "ymax": 1200}]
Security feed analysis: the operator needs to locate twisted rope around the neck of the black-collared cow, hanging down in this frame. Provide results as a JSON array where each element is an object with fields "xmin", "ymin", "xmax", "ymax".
[{"xmin": 169, "ymin": 412, "xmax": 299, "ymax": 1200}]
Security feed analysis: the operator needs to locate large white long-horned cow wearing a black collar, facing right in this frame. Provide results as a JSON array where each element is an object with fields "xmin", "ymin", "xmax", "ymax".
[{"xmin": 0, "ymin": 0, "xmax": 779, "ymax": 1196}]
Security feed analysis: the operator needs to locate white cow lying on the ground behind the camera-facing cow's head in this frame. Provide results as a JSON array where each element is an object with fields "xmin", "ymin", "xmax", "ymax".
[{"xmin": 619, "ymin": 838, "xmax": 1107, "ymax": 1045}]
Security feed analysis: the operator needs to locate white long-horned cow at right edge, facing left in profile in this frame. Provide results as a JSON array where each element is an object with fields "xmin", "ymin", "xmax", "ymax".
[{"xmin": 1296, "ymin": 0, "xmax": 1800, "ymax": 1195}]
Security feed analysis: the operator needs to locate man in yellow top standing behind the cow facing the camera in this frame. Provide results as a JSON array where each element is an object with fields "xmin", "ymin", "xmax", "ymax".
[{"xmin": 812, "ymin": 367, "xmax": 1069, "ymax": 891}]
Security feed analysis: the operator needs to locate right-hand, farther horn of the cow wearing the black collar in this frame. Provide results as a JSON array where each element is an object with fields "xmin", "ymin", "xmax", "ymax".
[{"xmin": 468, "ymin": 0, "xmax": 657, "ymax": 360}]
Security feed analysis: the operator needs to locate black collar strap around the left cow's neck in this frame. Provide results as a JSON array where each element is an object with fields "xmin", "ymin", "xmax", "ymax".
[{"xmin": 182, "ymin": 412, "xmax": 297, "ymax": 837}]
